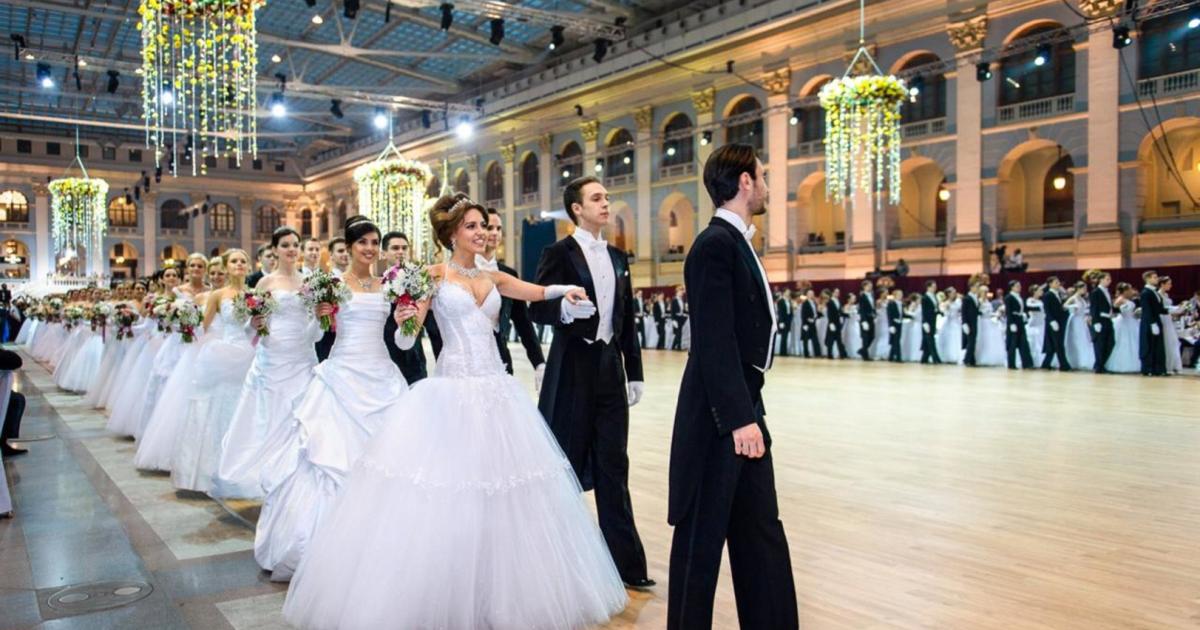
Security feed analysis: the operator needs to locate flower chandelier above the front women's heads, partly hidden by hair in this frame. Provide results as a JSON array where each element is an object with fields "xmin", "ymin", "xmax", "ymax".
[{"xmin": 354, "ymin": 156, "xmax": 433, "ymax": 258}]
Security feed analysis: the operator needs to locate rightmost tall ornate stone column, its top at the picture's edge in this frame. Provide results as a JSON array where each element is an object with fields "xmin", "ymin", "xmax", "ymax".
[{"xmin": 1075, "ymin": 0, "xmax": 1123, "ymax": 269}]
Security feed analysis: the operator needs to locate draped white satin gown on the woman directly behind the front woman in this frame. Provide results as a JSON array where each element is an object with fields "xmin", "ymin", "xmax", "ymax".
[{"xmin": 254, "ymin": 293, "xmax": 408, "ymax": 581}]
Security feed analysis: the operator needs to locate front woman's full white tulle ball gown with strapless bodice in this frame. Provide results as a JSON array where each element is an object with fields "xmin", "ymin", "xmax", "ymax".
[{"xmin": 276, "ymin": 282, "xmax": 628, "ymax": 630}]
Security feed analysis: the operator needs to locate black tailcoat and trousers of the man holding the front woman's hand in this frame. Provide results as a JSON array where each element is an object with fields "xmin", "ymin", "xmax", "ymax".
[{"xmin": 529, "ymin": 236, "xmax": 647, "ymax": 582}]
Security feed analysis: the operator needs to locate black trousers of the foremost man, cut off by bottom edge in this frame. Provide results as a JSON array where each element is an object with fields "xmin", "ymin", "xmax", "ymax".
[{"xmin": 667, "ymin": 434, "xmax": 799, "ymax": 630}]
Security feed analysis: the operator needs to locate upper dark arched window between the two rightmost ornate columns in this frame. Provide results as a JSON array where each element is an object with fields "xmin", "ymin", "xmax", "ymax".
[{"xmin": 998, "ymin": 24, "xmax": 1075, "ymax": 106}]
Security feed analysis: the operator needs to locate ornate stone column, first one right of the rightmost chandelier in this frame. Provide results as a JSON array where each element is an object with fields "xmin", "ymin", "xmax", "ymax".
[{"xmin": 947, "ymin": 16, "xmax": 988, "ymax": 274}]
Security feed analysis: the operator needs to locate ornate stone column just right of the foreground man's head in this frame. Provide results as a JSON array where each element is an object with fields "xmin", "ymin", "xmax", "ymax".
[{"xmin": 763, "ymin": 67, "xmax": 792, "ymax": 251}]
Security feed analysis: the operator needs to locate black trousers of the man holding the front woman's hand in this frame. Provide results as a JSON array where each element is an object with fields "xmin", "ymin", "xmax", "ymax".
[{"xmin": 556, "ymin": 342, "xmax": 647, "ymax": 582}]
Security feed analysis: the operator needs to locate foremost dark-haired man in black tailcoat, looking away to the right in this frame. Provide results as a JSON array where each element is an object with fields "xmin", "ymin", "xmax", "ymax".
[{"xmin": 667, "ymin": 144, "xmax": 799, "ymax": 630}]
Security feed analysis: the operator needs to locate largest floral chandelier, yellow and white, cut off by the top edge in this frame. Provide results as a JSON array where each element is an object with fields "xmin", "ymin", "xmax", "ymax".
[{"xmin": 138, "ymin": 0, "xmax": 265, "ymax": 175}]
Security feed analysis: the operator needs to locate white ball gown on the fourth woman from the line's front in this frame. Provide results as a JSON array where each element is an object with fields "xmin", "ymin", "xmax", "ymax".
[{"xmin": 171, "ymin": 299, "xmax": 254, "ymax": 492}]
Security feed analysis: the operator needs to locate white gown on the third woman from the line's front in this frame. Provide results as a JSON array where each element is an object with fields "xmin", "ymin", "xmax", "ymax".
[{"xmin": 209, "ymin": 290, "xmax": 322, "ymax": 498}]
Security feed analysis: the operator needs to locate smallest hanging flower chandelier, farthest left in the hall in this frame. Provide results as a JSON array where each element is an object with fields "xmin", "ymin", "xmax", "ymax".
[{"xmin": 49, "ymin": 178, "xmax": 108, "ymax": 257}]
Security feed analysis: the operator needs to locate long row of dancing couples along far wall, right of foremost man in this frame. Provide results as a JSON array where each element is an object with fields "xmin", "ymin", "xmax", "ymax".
[{"xmin": 775, "ymin": 270, "xmax": 1200, "ymax": 376}]
